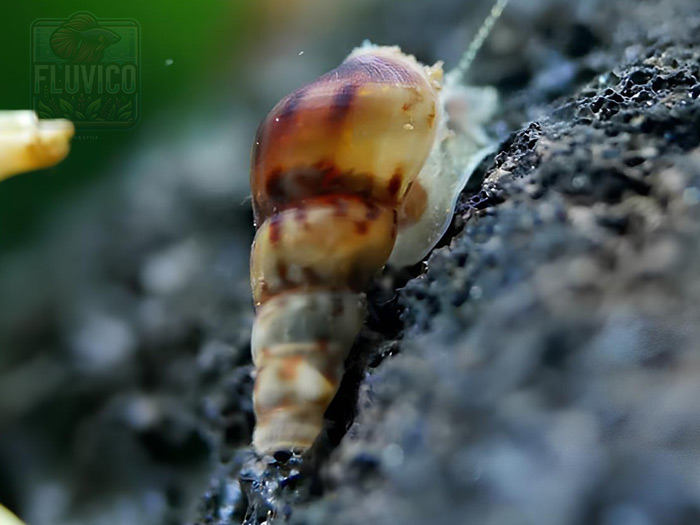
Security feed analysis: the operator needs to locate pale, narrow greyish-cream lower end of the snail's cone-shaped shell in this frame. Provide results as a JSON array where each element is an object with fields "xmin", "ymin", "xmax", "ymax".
[{"xmin": 251, "ymin": 292, "xmax": 365, "ymax": 453}]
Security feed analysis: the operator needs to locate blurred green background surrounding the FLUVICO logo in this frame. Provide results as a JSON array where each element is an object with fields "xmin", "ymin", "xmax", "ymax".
[{"xmin": 0, "ymin": 0, "xmax": 261, "ymax": 251}]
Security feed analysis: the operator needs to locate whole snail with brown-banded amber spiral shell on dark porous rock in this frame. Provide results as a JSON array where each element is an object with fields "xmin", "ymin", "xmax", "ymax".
[{"xmin": 250, "ymin": 0, "xmax": 507, "ymax": 454}]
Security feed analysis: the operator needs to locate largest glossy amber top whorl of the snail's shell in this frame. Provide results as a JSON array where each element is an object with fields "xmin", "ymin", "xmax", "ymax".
[{"xmin": 251, "ymin": 42, "xmax": 442, "ymax": 225}]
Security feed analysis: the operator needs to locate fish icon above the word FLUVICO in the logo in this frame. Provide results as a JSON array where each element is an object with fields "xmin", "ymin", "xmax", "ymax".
[{"xmin": 50, "ymin": 13, "xmax": 121, "ymax": 64}]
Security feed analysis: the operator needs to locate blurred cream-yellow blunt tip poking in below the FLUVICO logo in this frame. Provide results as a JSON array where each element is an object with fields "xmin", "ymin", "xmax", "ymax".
[{"xmin": 0, "ymin": 110, "xmax": 75, "ymax": 180}]
